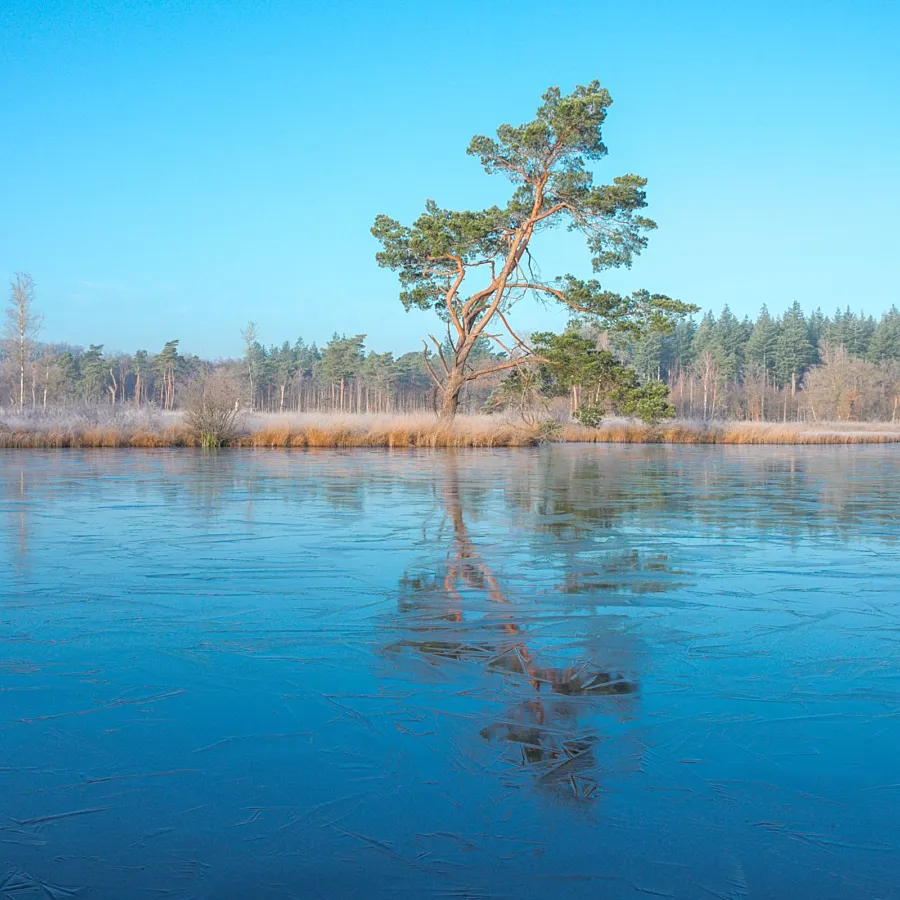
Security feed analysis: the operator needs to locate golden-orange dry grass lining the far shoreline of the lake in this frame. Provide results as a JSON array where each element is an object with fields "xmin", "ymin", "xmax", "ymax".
[{"xmin": 0, "ymin": 414, "xmax": 900, "ymax": 449}]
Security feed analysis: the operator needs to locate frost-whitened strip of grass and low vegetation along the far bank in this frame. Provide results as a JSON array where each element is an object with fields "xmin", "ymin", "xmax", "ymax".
[{"xmin": 0, "ymin": 406, "xmax": 900, "ymax": 449}]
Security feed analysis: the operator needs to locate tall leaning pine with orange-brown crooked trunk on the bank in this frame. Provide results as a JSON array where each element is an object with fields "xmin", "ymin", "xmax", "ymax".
[{"xmin": 372, "ymin": 81, "xmax": 695, "ymax": 418}]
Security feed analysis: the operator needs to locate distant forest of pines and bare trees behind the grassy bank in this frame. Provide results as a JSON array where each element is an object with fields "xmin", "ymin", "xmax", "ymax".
[{"xmin": 0, "ymin": 283, "xmax": 900, "ymax": 422}]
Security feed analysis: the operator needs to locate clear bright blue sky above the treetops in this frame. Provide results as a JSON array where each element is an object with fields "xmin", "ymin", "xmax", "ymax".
[{"xmin": 0, "ymin": 0, "xmax": 900, "ymax": 356}]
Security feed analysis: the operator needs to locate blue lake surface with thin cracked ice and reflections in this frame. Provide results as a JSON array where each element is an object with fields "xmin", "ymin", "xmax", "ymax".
[{"xmin": 0, "ymin": 446, "xmax": 900, "ymax": 900}]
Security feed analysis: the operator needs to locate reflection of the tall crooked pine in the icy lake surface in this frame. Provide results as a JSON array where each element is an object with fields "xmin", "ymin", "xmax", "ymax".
[{"xmin": 387, "ymin": 457, "xmax": 638, "ymax": 799}]
